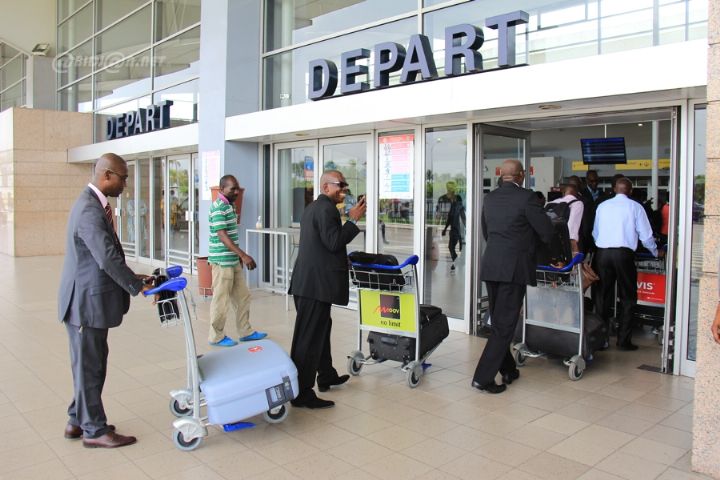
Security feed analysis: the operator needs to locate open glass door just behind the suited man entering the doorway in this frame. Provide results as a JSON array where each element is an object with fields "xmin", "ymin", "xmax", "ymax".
[{"xmin": 470, "ymin": 124, "xmax": 530, "ymax": 335}]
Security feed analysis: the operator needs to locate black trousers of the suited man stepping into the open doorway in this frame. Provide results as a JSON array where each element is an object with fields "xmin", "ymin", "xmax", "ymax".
[{"xmin": 473, "ymin": 282, "xmax": 527, "ymax": 385}]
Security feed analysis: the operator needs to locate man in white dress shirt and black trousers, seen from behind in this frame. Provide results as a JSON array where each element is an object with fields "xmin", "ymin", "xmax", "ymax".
[{"xmin": 593, "ymin": 177, "xmax": 658, "ymax": 350}]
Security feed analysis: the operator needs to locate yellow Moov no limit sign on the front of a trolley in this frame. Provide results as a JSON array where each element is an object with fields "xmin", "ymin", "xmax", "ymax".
[{"xmin": 359, "ymin": 290, "xmax": 417, "ymax": 332}]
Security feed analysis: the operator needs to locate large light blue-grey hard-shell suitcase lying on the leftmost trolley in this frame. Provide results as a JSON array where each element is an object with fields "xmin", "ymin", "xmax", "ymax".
[{"xmin": 198, "ymin": 340, "xmax": 298, "ymax": 425}]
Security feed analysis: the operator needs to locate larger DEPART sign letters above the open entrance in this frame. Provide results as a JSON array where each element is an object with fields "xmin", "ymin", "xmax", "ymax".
[{"xmin": 308, "ymin": 10, "xmax": 529, "ymax": 100}]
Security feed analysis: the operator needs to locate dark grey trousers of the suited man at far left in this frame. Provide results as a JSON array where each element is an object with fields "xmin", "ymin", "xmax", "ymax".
[{"xmin": 65, "ymin": 322, "xmax": 109, "ymax": 438}]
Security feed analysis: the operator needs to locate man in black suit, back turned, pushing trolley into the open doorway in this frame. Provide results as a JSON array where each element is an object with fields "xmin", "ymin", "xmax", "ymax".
[{"xmin": 472, "ymin": 160, "xmax": 553, "ymax": 393}]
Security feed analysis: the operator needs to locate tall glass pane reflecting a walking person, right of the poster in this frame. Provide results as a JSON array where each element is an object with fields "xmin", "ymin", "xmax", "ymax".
[{"xmin": 423, "ymin": 127, "xmax": 468, "ymax": 318}]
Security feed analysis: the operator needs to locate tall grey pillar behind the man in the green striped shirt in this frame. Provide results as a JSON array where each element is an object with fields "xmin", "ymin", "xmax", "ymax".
[{"xmin": 198, "ymin": 0, "xmax": 262, "ymax": 262}]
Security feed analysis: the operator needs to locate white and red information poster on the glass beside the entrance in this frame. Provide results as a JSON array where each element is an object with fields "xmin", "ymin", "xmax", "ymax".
[{"xmin": 379, "ymin": 133, "xmax": 415, "ymax": 200}]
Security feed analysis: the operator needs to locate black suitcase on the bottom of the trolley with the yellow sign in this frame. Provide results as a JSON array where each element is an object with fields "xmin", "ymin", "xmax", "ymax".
[{"xmin": 368, "ymin": 305, "xmax": 450, "ymax": 365}]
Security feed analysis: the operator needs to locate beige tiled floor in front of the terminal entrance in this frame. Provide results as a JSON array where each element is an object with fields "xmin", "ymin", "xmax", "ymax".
[{"xmin": 0, "ymin": 256, "xmax": 705, "ymax": 480}]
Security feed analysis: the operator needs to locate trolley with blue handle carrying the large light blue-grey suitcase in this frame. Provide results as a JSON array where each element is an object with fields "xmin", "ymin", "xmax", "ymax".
[{"xmin": 143, "ymin": 266, "xmax": 298, "ymax": 451}]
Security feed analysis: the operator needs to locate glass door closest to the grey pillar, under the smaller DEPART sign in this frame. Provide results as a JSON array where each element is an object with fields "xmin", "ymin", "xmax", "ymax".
[{"xmin": 166, "ymin": 155, "xmax": 193, "ymax": 269}]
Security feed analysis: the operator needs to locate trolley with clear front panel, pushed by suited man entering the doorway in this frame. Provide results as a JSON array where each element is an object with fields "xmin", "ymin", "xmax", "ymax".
[{"xmin": 513, "ymin": 253, "xmax": 592, "ymax": 380}]
